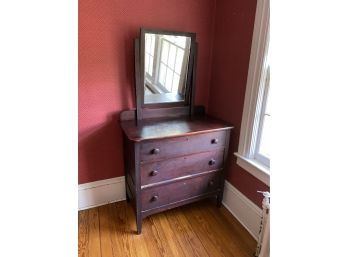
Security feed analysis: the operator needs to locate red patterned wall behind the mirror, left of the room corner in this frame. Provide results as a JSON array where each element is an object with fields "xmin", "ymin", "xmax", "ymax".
[{"xmin": 78, "ymin": 0, "xmax": 215, "ymax": 183}]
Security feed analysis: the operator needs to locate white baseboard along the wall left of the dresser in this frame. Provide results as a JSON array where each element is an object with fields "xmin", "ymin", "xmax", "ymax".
[{"xmin": 78, "ymin": 176, "xmax": 126, "ymax": 210}]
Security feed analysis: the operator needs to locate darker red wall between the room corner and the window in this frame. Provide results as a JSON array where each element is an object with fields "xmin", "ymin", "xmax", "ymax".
[{"xmin": 208, "ymin": 0, "xmax": 269, "ymax": 206}]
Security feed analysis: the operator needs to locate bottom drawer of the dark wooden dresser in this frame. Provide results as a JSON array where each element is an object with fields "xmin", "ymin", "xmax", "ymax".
[{"xmin": 141, "ymin": 171, "xmax": 221, "ymax": 211}]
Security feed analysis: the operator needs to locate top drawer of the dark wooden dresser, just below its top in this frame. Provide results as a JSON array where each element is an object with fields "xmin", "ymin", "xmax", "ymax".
[{"xmin": 140, "ymin": 131, "xmax": 226, "ymax": 162}]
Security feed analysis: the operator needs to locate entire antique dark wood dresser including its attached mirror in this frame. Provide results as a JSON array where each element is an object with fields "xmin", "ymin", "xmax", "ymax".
[{"xmin": 120, "ymin": 29, "xmax": 233, "ymax": 234}]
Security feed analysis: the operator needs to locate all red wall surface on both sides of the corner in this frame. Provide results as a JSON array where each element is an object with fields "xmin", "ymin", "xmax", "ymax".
[{"xmin": 79, "ymin": 0, "xmax": 269, "ymax": 206}]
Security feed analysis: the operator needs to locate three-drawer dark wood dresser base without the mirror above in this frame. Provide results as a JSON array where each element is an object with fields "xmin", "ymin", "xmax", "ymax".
[{"xmin": 121, "ymin": 116, "xmax": 233, "ymax": 234}]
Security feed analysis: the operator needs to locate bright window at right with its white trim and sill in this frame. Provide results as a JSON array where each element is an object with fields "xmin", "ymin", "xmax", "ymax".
[{"xmin": 235, "ymin": 0, "xmax": 272, "ymax": 185}]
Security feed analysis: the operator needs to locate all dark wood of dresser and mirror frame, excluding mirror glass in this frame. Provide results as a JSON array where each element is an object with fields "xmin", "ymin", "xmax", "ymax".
[{"xmin": 120, "ymin": 39, "xmax": 233, "ymax": 234}]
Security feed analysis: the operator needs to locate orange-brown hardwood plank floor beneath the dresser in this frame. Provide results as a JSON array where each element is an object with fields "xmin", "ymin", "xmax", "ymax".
[{"xmin": 78, "ymin": 200, "xmax": 256, "ymax": 257}]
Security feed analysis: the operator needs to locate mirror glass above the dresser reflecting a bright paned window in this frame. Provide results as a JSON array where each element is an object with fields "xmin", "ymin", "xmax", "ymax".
[{"xmin": 144, "ymin": 33, "xmax": 191, "ymax": 104}]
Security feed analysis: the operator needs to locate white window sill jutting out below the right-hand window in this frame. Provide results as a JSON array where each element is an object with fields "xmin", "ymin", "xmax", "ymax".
[{"xmin": 234, "ymin": 153, "xmax": 270, "ymax": 186}]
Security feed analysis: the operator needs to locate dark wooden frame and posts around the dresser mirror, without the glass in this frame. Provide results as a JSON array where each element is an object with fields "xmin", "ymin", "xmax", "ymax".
[{"xmin": 134, "ymin": 28, "xmax": 197, "ymax": 120}]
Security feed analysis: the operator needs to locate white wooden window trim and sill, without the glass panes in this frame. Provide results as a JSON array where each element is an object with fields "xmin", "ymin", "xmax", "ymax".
[{"xmin": 235, "ymin": 0, "xmax": 270, "ymax": 186}]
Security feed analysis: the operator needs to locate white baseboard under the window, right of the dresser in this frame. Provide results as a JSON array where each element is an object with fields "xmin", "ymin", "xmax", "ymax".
[{"xmin": 222, "ymin": 180, "xmax": 262, "ymax": 241}]
